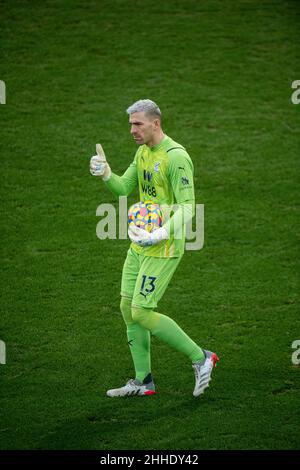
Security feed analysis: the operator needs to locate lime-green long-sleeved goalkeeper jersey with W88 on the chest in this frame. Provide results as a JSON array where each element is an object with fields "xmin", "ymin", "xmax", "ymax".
[{"xmin": 106, "ymin": 135, "xmax": 195, "ymax": 258}]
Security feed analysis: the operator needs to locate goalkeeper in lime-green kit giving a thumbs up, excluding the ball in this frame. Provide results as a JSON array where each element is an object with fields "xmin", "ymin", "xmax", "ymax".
[{"xmin": 90, "ymin": 99, "xmax": 218, "ymax": 397}]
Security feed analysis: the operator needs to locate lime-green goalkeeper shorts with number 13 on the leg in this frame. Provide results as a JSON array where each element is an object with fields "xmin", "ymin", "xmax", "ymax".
[{"xmin": 121, "ymin": 248, "xmax": 182, "ymax": 309}]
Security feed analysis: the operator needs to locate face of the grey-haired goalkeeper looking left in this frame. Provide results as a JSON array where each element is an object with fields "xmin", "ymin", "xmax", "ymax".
[{"xmin": 129, "ymin": 111, "xmax": 159, "ymax": 145}]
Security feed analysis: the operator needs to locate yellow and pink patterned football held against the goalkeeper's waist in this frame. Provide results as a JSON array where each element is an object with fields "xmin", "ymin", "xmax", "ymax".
[{"xmin": 128, "ymin": 201, "xmax": 162, "ymax": 232}]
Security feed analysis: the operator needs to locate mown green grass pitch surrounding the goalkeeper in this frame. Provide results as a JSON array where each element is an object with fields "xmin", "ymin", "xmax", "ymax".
[{"xmin": 0, "ymin": 0, "xmax": 300, "ymax": 450}]
